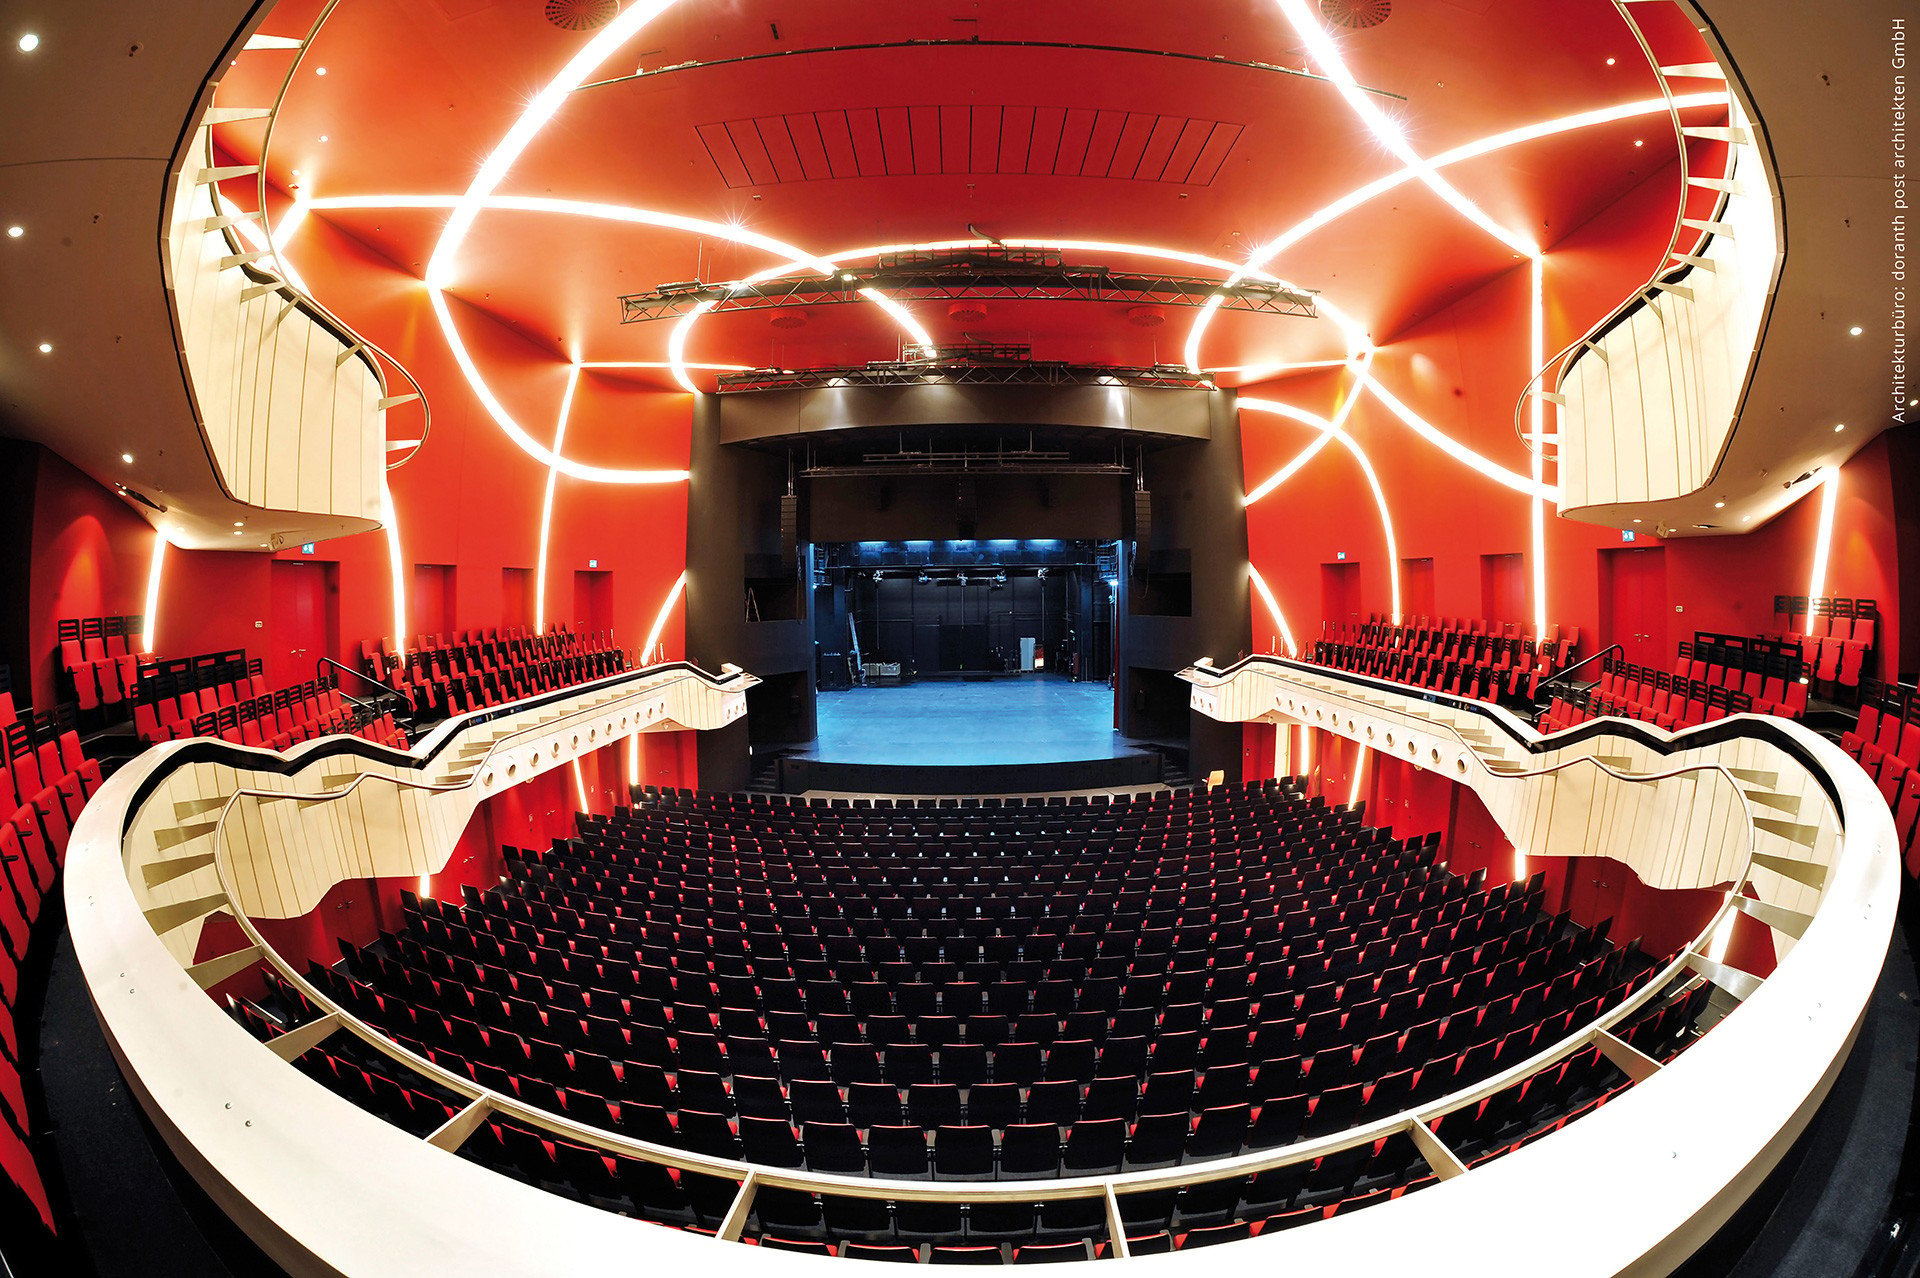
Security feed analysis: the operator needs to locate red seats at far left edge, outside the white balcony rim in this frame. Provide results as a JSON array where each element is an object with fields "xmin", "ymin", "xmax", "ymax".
[{"xmin": 0, "ymin": 720, "xmax": 102, "ymax": 1230}]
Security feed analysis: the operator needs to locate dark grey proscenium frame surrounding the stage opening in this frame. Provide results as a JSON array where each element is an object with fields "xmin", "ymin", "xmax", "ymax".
[{"xmin": 687, "ymin": 384, "xmax": 1252, "ymax": 789}]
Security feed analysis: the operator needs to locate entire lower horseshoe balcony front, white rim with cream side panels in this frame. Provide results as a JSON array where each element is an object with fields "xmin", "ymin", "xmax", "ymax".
[{"xmin": 67, "ymin": 660, "xmax": 1897, "ymax": 1274}]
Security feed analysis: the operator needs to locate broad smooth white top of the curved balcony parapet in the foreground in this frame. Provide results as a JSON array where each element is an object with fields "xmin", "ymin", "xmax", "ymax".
[{"xmin": 67, "ymin": 652, "xmax": 1897, "ymax": 1276}]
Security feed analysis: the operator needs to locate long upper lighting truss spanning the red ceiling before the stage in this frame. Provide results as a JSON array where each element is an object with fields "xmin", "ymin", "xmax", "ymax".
[{"xmin": 620, "ymin": 248, "xmax": 1319, "ymax": 324}]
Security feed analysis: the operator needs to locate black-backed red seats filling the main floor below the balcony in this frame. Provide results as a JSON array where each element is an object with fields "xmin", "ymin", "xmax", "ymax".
[{"xmin": 224, "ymin": 775, "xmax": 1692, "ymax": 1263}]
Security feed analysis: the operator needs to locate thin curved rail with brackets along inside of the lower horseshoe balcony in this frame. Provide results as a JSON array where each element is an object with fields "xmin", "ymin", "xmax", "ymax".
[{"xmin": 183, "ymin": 667, "xmax": 1757, "ymax": 1257}]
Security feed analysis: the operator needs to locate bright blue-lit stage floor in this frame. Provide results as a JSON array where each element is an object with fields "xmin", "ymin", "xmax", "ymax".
[{"xmin": 795, "ymin": 674, "xmax": 1137, "ymax": 766}]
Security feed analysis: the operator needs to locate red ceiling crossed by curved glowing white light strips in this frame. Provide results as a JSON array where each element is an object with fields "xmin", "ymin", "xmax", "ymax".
[{"xmin": 210, "ymin": 0, "xmax": 1712, "ymax": 384}]
